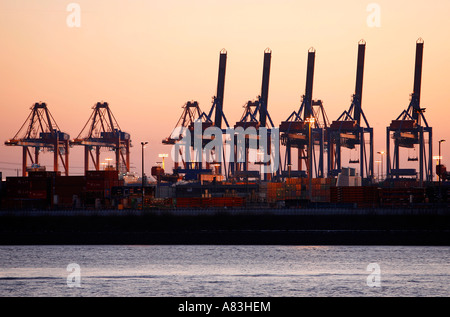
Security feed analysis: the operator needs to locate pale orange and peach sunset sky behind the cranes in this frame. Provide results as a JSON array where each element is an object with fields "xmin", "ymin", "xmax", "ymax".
[{"xmin": 0, "ymin": 0, "xmax": 450, "ymax": 177}]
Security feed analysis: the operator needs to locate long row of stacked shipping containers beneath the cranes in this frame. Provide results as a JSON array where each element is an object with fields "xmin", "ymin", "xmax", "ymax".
[{"xmin": 2, "ymin": 170, "xmax": 447, "ymax": 209}]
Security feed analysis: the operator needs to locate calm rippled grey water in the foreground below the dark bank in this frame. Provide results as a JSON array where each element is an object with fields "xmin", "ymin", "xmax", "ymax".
[{"xmin": 0, "ymin": 245, "xmax": 450, "ymax": 297}]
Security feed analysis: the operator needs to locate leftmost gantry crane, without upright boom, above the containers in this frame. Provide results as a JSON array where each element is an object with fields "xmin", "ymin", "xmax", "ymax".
[{"xmin": 5, "ymin": 103, "xmax": 70, "ymax": 176}]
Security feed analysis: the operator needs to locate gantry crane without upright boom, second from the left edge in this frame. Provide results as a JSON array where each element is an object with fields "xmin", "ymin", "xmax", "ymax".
[{"xmin": 70, "ymin": 102, "xmax": 132, "ymax": 173}]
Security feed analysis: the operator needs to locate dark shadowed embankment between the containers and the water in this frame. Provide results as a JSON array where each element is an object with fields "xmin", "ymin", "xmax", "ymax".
[{"xmin": 0, "ymin": 210, "xmax": 450, "ymax": 246}]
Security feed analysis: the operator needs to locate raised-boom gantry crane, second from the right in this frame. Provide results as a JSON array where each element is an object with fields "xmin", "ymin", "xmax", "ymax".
[{"xmin": 327, "ymin": 40, "xmax": 374, "ymax": 183}]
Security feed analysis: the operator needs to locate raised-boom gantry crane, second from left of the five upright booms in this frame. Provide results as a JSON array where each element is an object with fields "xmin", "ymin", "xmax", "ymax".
[{"xmin": 229, "ymin": 48, "xmax": 275, "ymax": 180}]
